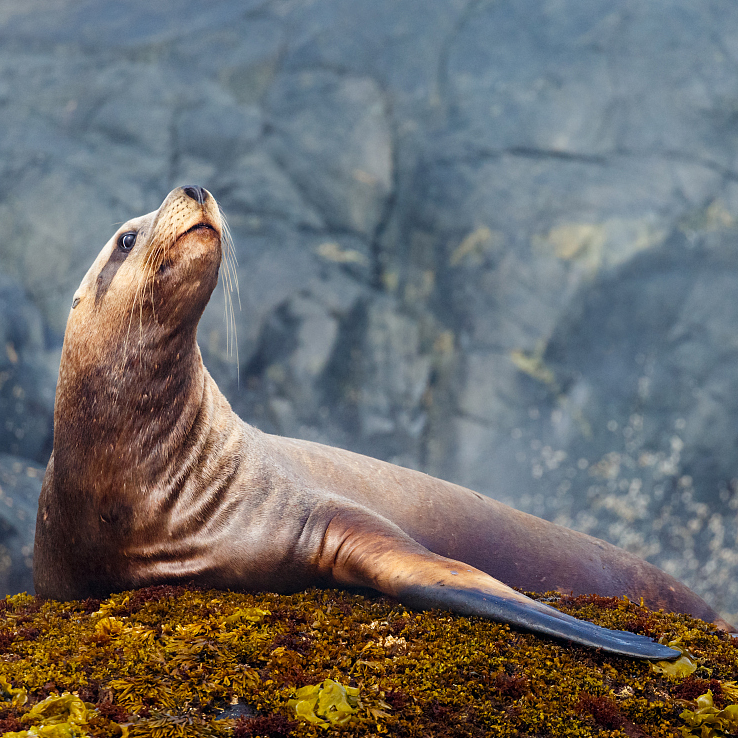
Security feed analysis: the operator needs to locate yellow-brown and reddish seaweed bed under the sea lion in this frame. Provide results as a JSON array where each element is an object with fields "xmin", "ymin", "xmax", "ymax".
[{"xmin": 0, "ymin": 586, "xmax": 738, "ymax": 738}]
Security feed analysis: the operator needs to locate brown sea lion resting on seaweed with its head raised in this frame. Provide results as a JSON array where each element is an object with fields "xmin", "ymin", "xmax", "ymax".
[{"xmin": 34, "ymin": 186, "xmax": 730, "ymax": 659}]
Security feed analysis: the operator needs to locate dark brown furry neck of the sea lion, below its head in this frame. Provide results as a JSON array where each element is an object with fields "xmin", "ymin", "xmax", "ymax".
[{"xmin": 54, "ymin": 331, "xmax": 206, "ymax": 507}]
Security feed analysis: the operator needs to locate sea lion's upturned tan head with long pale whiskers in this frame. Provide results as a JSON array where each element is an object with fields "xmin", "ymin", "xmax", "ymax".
[{"xmin": 65, "ymin": 186, "xmax": 224, "ymax": 346}]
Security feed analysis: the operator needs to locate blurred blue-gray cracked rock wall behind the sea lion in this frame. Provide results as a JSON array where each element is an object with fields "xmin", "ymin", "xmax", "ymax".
[{"xmin": 0, "ymin": 0, "xmax": 738, "ymax": 623}]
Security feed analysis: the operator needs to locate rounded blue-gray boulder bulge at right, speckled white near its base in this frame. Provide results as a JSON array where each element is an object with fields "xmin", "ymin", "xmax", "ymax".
[{"xmin": 498, "ymin": 233, "xmax": 738, "ymax": 608}]
